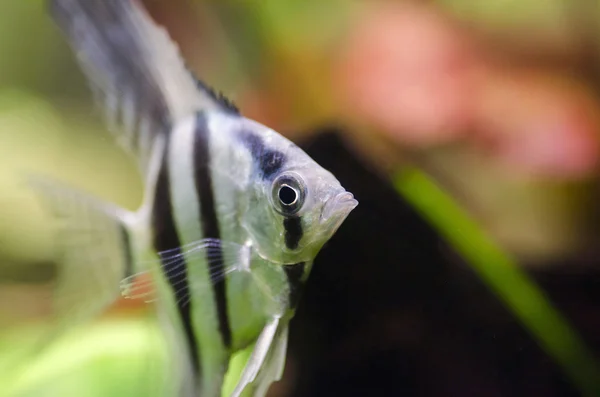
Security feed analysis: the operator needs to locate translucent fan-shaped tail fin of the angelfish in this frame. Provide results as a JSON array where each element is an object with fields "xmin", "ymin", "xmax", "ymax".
[{"xmin": 2, "ymin": 177, "xmax": 132, "ymax": 380}]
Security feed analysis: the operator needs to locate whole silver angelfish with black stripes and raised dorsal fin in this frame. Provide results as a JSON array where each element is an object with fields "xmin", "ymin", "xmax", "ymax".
[{"xmin": 42, "ymin": 0, "xmax": 358, "ymax": 397}]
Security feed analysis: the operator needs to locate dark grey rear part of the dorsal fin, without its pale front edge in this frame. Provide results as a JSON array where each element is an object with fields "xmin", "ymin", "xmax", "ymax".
[{"xmin": 51, "ymin": 0, "xmax": 173, "ymax": 167}]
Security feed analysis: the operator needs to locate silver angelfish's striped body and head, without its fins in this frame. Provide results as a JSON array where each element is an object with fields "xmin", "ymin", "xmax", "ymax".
[{"xmin": 144, "ymin": 112, "xmax": 356, "ymax": 395}]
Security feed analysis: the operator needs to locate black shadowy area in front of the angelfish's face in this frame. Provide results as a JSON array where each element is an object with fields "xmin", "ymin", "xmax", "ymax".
[{"xmin": 289, "ymin": 129, "xmax": 600, "ymax": 397}]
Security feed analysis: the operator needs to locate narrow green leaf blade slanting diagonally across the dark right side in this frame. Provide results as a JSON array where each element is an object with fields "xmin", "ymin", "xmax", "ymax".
[{"xmin": 395, "ymin": 168, "xmax": 600, "ymax": 397}]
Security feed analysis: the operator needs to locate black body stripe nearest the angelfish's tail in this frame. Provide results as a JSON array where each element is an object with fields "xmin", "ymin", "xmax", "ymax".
[{"xmin": 152, "ymin": 144, "xmax": 200, "ymax": 374}]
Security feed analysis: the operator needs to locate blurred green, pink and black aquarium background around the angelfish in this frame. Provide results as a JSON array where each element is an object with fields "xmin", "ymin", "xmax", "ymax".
[{"xmin": 0, "ymin": 0, "xmax": 600, "ymax": 396}]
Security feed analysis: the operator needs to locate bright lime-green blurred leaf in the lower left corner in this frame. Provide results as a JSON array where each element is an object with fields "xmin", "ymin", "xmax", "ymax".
[{"xmin": 0, "ymin": 318, "xmax": 170, "ymax": 397}]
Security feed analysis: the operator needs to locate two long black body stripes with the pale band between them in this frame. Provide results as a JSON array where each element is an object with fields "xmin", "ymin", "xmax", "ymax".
[{"xmin": 152, "ymin": 113, "xmax": 239, "ymax": 395}]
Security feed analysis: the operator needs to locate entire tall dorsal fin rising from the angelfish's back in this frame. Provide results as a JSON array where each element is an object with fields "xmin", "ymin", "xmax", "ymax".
[{"xmin": 50, "ymin": 0, "xmax": 236, "ymax": 171}]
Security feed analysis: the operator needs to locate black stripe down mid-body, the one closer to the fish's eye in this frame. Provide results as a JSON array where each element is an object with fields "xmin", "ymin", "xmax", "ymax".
[{"xmin": 194, "ymin": 113, "xmax": 231, "ymax": 348}]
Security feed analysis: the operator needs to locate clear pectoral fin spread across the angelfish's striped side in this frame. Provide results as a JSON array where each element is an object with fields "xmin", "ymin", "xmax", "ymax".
[{"xmin": 120, "ymin": 238, "xmax": 250, "ymax": 302}]
